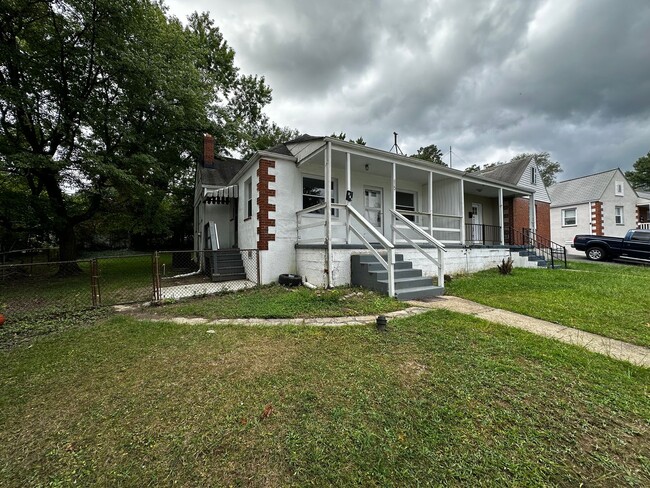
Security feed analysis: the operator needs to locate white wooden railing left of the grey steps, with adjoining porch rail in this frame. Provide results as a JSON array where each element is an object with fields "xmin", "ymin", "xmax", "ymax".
[{"xmin": 296, "ymin": 203, "xmax": 395, "ymax": 297}]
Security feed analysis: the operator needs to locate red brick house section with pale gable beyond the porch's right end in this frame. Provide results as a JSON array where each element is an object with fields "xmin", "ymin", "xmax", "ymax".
[{"xmin": 479, "ymin": 156, "xmax": 551, "ymax": 239}]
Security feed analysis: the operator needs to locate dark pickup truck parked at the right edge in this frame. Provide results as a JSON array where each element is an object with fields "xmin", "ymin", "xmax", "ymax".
[{"xmin": 572, "ymin": 229, "xmax": 650, "ymax": 261}]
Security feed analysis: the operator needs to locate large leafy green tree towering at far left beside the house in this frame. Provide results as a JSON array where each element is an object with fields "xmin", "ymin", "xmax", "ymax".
[{"xmin": 0, "ymin": 0, "xmax": 270, "ymax": 260}]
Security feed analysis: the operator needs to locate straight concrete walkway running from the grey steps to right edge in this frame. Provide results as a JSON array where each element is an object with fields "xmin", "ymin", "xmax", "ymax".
[{"xmin": 409, "ymin": 296, "xmax": 650, "ymax": 368}]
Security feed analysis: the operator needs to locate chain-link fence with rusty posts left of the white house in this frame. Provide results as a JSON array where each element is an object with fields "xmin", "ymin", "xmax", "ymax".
[{"xmin": 0, "ymin": 249, "xmax": 260, "ymax": 321}]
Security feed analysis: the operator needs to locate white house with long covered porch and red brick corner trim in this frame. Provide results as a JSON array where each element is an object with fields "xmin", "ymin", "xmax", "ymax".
[{"xmin": 195, "ymin": 135, "xmax": 535, "ymax": 296}]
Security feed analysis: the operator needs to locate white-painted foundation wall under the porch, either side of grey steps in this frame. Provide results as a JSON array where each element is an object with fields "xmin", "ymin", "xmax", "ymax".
[{"xmin": 296, "ymin": 248, "xmax": 538, "ymax": 288}]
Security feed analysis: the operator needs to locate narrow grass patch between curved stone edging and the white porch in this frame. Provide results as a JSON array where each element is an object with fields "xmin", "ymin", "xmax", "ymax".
[{"xmin": 148, "ymin": 285, "xmax": 407, "ymax": 319}]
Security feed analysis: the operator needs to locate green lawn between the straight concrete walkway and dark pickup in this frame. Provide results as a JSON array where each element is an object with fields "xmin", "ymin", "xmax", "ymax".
[{"xmin": 447, "ymin": 262, "xmax": 650, "ymax": 347}]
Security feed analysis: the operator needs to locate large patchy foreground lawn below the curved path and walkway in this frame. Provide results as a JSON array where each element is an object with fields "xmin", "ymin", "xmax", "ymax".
[{"xmin": 0, "ymin": 311, "xmax": 650, "ymax": 487}]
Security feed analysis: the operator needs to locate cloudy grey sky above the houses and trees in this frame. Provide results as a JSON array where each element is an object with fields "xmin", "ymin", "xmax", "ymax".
[{"xmin": 167, "ymin": 0, "xmax": 650, "ymax": 180}]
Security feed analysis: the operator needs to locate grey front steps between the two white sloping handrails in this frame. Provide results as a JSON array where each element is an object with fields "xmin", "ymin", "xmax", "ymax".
[{"xmin": 350, "ymin": 254, "xmax": 445, "ymax": 300}]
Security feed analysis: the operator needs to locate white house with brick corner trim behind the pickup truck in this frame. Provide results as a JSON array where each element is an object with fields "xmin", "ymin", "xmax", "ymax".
[{"xmin": 548, "ymin": 168, "xmax": 639, "ymax": 252}]
